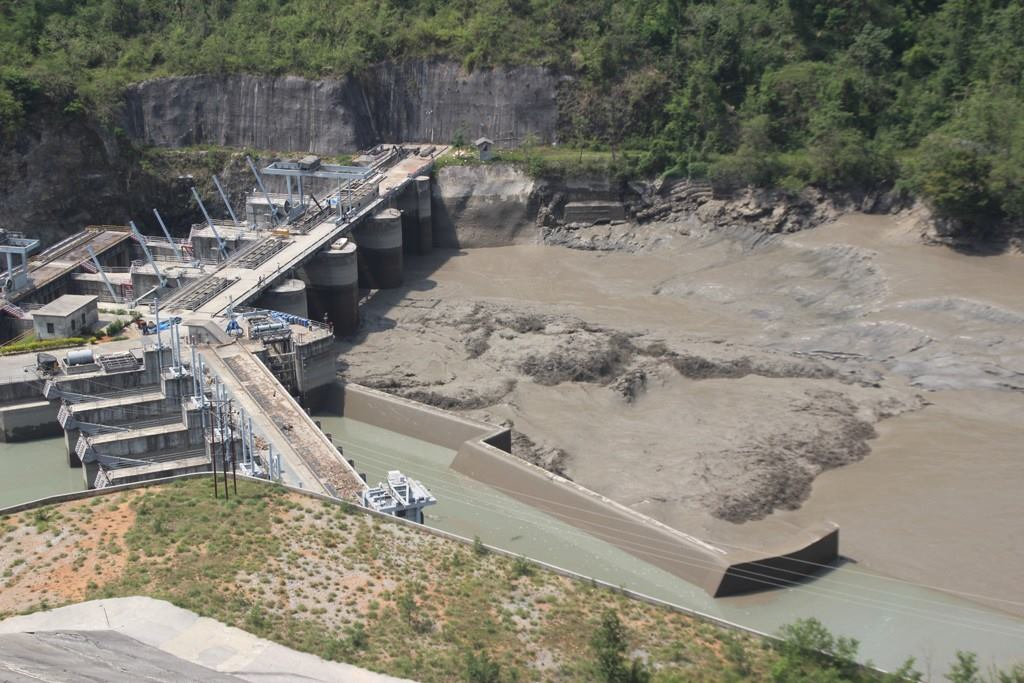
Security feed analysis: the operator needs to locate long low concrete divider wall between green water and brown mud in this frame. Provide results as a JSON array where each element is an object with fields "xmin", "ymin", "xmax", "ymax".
[{"xmin": 327, "ymin": 384, "xmax": 839, "ymax": 597}]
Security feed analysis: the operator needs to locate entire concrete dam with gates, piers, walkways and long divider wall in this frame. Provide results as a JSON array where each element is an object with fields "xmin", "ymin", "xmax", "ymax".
[{"xmin": 4, "ymin": 144, "xmax": 839, "ymax": 596}]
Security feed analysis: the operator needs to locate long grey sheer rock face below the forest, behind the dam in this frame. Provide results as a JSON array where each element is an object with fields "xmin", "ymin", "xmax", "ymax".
[{"xmin": 122, "ymin": 61, "xmax": 560, "ymax": 154}]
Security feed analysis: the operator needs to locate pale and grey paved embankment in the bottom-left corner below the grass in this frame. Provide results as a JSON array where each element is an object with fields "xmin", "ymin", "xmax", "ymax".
[{"xmin": 0, "ymin": 597, "xmax": 415, "ymax": 683}]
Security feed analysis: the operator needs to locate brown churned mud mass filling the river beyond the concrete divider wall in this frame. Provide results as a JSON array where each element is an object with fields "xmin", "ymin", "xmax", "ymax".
[{"xmin": 339, "ymin": 215, "xmax": 1024, "ymax": 609}]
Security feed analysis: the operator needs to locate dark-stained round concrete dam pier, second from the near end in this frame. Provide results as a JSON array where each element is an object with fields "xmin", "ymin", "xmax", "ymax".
[{"xmin": 305, "ymin": 239, "xmax": 360, "ymax": 338}]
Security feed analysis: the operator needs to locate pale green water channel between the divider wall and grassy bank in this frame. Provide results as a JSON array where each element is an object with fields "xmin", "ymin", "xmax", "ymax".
[{"xmin": 316, "ymin": 415, "xmax": 1024, "ymax": 679}]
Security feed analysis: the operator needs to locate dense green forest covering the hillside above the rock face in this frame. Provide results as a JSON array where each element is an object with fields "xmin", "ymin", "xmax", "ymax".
[{"xmin": 0, "ymin": 0, "xmax": 1024, "ymax": 231}]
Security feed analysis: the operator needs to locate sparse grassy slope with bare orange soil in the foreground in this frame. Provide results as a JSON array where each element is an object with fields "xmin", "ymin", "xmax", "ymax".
[{"xmin": 0, "ymin": 479, "xmax": 774, "ymax": 681}]
